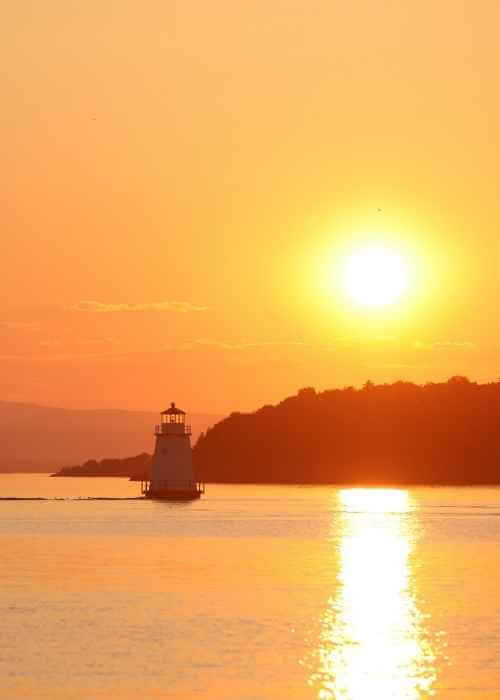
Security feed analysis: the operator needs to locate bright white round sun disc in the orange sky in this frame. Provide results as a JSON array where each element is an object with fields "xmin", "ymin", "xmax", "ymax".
[{"xmin": 343, "ymin": 246, "xmax": 410, "ymax": 307}]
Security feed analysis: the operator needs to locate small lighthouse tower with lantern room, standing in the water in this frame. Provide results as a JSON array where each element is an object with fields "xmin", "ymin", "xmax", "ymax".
[{"xmin": 144, "ymin": 403, "xmax": 205, "ymax": 500}]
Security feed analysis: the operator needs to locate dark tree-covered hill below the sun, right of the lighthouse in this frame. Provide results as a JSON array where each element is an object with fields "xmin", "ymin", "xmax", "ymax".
[{"xmin": 194, "ymin": 377, "xmax": 500, "ymax": 484}]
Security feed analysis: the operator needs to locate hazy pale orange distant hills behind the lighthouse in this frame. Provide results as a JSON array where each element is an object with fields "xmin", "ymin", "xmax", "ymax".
[{"xmin": 0, "ymin": 401, "xmax": 221, "ymax": 472}]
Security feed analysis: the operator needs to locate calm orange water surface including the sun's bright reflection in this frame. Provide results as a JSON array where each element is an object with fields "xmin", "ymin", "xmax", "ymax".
[{"xmin": 0, "ymin": 475, "xmax": 500, "ymax": 700}]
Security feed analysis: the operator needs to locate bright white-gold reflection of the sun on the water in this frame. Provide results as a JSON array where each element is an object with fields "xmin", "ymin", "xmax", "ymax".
[{"xmin": 310, "ymin": 489, "xmax": 437, "ymax": 700}]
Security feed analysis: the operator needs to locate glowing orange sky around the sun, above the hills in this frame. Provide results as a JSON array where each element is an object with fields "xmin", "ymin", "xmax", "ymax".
[{"xmin": 0, "ymin": 0, "xmax": 500, "ymax": 413}]
